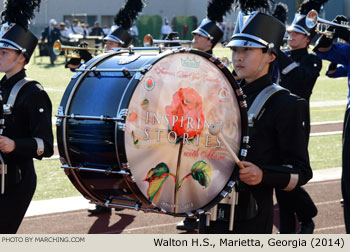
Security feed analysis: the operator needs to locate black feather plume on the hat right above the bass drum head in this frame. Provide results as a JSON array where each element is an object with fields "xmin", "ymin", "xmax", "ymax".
[{"xmin": 207, "ymin": 0, "xmax": 235, "ymax": 22}]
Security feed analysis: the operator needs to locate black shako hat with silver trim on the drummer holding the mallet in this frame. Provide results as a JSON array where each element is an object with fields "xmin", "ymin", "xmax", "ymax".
[{"xmin": 226, "ymin": 0, "xmax": 286, "ymax": 54}]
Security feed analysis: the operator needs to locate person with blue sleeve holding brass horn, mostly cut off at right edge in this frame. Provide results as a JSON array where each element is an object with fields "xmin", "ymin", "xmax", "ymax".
[{"xmin": 314, "ymin": 16, "xmax": 350, "ymax": 234}]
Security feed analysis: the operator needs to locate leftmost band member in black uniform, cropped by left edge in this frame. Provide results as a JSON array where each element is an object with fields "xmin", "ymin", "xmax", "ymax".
[{"xmin": 0, "ymin": 0, "xmax": 53, "ymax": 234}]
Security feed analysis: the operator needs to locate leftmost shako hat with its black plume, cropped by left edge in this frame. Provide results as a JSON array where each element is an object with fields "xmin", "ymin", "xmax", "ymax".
[{"xmin": 0, "ymin": 0, "xmax": 41, "ymax": 62}]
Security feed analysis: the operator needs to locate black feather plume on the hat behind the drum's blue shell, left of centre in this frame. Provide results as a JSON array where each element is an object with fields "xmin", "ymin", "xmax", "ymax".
[{"xmin": 114, "ymin": 0, "xmax": 145, "ymax": 30}]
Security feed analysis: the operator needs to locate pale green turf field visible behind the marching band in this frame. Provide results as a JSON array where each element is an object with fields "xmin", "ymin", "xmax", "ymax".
[{"xmin": 28, "ymin": 48, "xmax": 348, "ymax": 200}]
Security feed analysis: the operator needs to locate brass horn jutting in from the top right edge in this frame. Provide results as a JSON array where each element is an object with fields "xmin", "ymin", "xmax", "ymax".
[{"xmin": 305, "ymin": 10, "xmax": 350, "ymax": 38}]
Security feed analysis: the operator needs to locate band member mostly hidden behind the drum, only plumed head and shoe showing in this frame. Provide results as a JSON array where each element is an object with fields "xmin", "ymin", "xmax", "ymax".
[{"xmin": 176, "ymin": 0, "xmax": 234, "ymax": 231}]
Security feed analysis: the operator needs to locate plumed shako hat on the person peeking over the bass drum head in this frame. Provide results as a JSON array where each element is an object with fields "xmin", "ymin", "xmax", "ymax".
[{"xmin": 192, "ymin": 0, "xmax": 235, "ymax": 47}]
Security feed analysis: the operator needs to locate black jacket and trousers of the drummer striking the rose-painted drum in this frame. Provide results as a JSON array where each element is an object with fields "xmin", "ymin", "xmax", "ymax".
[{"xmin": 235, "ymin": 75, "xmax": 312, "ymax": 233}]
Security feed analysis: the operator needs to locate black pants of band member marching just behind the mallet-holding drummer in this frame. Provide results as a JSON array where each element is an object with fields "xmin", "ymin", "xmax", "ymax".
[{"xmin": 276, "ymin": 187, "xmax": 317, "ymax": 234}]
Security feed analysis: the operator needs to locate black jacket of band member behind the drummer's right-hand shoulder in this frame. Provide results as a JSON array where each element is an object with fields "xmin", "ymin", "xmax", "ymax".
[{"xmin": 278, "ymin": 48, "xmax": 322, "ymax": 101}]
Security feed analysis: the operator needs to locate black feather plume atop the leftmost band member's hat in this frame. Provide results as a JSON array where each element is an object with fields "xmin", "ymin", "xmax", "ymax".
[{"xmin": 1, "ymin": 0, "xmax": 41, "ymax": 29}]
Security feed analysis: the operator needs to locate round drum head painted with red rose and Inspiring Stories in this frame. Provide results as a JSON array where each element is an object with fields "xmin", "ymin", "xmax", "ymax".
[{"xmin": 125, "ymin": 53, "xmax": 242, "ymax": 214}]
